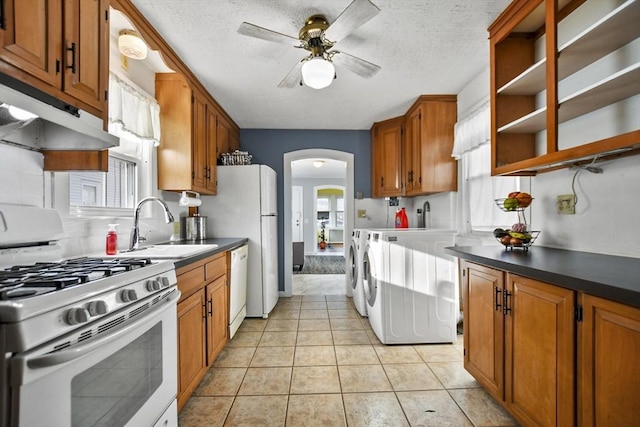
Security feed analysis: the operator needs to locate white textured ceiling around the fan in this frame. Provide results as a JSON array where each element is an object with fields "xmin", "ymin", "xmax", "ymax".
[{"xmin": 132, "ymin": 0, "xmax": 510, "ymax": 129}]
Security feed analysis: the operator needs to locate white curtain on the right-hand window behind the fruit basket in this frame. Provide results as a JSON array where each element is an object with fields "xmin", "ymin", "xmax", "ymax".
[{"xmin": 451, "ymin": 100, "xmax": 520, "ymax": 233}]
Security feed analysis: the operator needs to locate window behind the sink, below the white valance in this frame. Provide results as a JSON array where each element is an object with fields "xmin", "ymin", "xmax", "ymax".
[{"xmin": 69, "ymin": 153, "xmax": 138, "ymax": 208}]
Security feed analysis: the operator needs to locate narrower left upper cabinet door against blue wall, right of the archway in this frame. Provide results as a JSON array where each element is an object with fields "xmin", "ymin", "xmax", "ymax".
[{"xmin": 371, "ymin": 117, "xmax": 404, "ymax": 197}]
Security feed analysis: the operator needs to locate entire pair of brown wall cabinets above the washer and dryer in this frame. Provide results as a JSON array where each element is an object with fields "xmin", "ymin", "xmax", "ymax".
[{"xmin": 371, "ymin": 95, "xmax": 458, "ymax": 197}]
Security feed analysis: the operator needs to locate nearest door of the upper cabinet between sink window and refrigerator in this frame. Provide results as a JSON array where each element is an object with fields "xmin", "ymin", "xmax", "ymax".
[{"xmin": 191, "ymin": 91, "xmax": 208, "ymax": 193}]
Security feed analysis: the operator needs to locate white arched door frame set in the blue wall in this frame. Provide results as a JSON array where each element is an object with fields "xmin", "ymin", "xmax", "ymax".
[{"xmin": 280, "ymin": 148, "xmax": 355, "ymax": 297}]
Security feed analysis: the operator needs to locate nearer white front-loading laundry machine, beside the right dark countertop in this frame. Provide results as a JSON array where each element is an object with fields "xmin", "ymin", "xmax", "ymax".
[{"xmin": 364, "ymin": 229, "xmax": 459, "ymax": 344}]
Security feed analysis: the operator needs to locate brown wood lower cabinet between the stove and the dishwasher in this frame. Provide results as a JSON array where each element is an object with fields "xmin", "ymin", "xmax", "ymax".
[{"xmin": 176, "ymin": 252, "xmax": 229, "ymax": 410}]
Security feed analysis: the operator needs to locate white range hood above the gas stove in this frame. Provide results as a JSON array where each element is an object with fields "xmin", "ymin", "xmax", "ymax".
[{"xmin": 0, "ymin": 74, "xmax": 119, "ymax": 150}]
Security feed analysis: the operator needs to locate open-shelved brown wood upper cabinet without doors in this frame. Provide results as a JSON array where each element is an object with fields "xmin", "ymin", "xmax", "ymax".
[{"xmin": 489, "ymin": 0, "xmax": 640, "ymax": 175}]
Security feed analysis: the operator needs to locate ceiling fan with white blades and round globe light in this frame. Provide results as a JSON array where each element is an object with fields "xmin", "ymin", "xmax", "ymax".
[{"xmin": 238, "ymin": 0, "xmax": 380, "ymax": 89}]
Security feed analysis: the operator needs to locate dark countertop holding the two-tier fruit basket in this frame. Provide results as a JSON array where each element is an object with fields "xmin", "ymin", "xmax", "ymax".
[{"xmin": 445, "ymin": 245, "xmax": 640, "ymax": 307}]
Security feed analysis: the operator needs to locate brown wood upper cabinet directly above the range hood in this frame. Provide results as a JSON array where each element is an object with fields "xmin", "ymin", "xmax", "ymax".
[{"xmin": 0, "ymin": 0, "xmax": 109, "ymax": 120}]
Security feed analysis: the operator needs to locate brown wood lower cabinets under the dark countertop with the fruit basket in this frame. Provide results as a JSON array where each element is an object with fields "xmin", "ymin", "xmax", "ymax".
[{"xmin": 463, "ymin": 262, "xmax": 640, "ymax": 426}]
